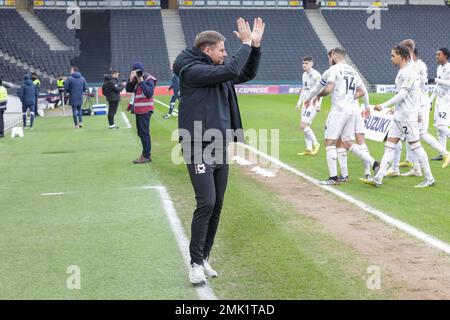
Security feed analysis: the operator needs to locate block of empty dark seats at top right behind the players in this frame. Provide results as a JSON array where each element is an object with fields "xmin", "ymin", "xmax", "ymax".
[{"xmin": 322, "ymin": 6, "xmax": 450, "ymax": 84}]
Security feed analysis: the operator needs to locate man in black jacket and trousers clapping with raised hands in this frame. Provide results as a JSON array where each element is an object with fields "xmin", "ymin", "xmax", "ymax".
[{"xmin": 174, "ymin": 18, "xmax": 264, "ymax": 285}]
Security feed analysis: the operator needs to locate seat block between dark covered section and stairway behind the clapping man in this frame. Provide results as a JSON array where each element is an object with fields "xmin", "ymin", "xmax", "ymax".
[{"xmin": 110, "ymin": 9, "xmax": 171, "ymax": 81}]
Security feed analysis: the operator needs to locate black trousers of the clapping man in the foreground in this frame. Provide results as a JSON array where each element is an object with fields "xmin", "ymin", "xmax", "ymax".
[{"xmin": 187, "ymin": 163, "xmax": 229, "ymax": 265}]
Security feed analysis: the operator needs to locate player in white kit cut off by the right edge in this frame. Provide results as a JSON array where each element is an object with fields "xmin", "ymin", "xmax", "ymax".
[{"xmin": 431, "ymin": 48, "xmax": 450, "ymax": 161}]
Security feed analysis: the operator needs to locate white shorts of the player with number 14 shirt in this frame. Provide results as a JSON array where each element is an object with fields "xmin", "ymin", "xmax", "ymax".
[{"xmin": 325, "ymin": 113, "xmax": 355, "ymax": 141}]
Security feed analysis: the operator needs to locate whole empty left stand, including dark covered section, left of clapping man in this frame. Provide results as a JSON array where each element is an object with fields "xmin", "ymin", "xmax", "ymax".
[{"xmin": 0, "ymin": 8, "xmax": 171, "ymax": 83}]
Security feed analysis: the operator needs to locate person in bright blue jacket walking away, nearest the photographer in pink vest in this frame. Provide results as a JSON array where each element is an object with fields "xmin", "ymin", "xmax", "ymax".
[{"xmin": 64, "ymin": 67, "xmax": 88, "ymax": 128}]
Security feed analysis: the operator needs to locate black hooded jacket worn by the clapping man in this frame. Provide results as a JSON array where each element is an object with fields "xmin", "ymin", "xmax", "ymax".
[{"xmin": 174, "ymin": 45, "xmax": 261, "ymax": 142}]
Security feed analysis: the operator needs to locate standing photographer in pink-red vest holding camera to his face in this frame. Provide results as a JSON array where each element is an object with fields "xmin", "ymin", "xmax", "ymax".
[{"xmin": 125, "ymin": 62, "xmax": 157, "ymax": 164}]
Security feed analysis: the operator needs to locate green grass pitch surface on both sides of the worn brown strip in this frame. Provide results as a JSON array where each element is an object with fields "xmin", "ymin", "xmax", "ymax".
[{"xmin": 0, "ymin": 95, "xmax": 450, "ymax": 299}]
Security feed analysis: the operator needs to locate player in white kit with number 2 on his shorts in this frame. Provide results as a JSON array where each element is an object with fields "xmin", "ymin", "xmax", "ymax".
[{"xmin": 361, "ymin": 44, "xmax": 435, "ymax": 188}]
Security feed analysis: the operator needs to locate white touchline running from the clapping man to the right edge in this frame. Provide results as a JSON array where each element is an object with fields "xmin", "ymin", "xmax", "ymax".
[{"xmin": 236, "ymin": 142, "xmax": 450, "ymax": 254}]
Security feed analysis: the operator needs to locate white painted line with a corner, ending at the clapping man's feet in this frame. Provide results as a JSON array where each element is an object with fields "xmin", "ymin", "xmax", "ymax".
[{"xmin": 142, "ymin": 186, "xmax": 217, "ymax": 300}]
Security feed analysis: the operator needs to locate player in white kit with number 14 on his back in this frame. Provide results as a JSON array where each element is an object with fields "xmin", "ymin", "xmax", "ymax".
[{"xmin": 305, "ymin": 48, "xmax": 379, "ymax": 185}]
